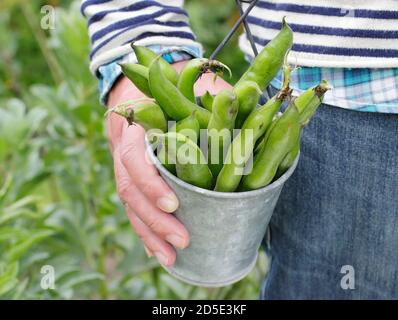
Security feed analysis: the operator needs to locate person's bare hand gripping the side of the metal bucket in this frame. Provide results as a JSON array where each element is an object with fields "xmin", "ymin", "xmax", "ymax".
[{"xmin": 107, "ymin": 62, "xmax": 235, "ymax": 266}]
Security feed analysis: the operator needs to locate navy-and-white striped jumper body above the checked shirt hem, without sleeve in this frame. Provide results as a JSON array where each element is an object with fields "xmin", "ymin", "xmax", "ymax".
[{"xmin": 240, "ymin": 0, "xmax": 398, "ymax": 68}]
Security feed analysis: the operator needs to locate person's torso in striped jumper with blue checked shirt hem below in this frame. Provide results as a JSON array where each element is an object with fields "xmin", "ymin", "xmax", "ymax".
[{"xmin": 240, "ymin": 0, "xmax": 398, "ymax": 113}]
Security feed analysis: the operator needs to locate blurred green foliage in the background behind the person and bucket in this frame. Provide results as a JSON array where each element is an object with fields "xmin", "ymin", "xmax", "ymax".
[{"xmin": 0, "ymin": 0, "xmax": 266, "ymax": 299}]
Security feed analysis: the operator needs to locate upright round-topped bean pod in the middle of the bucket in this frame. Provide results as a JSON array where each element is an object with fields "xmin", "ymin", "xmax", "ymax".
[{"xmin": 207, "ymin": 90, "xmax": 239, "ymax": 177}]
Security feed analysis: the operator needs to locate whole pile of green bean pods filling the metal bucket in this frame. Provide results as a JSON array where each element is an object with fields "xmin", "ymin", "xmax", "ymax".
[{"xmin": 111, "ymin": 20, "xmax": 329, "ymax": 192}]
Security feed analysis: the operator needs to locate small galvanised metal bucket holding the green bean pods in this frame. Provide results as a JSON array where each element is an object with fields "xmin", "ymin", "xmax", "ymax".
[{"xmin": 147, "ymin": 141, "xmax": 299, "ymax": 287}]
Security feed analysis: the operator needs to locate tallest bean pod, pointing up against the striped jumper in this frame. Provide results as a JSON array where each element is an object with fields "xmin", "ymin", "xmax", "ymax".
[{"xmin": 238, "ymin": 18, "xmax": 293, "ymax": 91}]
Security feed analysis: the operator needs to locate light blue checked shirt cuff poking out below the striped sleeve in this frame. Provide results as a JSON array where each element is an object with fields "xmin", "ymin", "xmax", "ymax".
[{"xmin": 97, "ymin": 45, "xmax": 202, "ymax": 105}]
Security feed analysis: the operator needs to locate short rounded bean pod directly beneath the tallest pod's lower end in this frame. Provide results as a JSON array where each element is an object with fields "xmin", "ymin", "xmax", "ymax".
[{"xmin": 234, "ymin": 81, "xmax": 262, "ymax": 128}]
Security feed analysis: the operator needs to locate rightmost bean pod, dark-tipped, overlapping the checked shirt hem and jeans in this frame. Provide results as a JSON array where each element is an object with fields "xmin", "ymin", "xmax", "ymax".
[{"xmin": 294, "ymin": 80, "xmax": 330, "ymax": 126}]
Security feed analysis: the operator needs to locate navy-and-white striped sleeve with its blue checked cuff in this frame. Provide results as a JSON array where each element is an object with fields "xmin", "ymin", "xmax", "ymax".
[{"xmin": 81, "ymin": 0, "xmax": 202, "ymax": 103}]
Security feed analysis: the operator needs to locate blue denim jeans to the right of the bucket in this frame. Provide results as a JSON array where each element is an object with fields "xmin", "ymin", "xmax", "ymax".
[{"xmin": 261, "ymin": 88, "xmax": 398, "ymax": 299}]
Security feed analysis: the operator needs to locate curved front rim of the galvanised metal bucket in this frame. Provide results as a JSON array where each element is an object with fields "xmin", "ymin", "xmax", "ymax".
[{"xmin": 145, "ymin": 136, "xmax": 301, "ymax": 199}]
